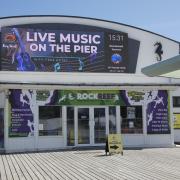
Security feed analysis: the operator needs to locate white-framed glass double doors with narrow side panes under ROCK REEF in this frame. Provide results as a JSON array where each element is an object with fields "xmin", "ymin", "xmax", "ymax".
[{"xmin": 67, "ymin": 106, "xmax": 119, "ymax": 146}]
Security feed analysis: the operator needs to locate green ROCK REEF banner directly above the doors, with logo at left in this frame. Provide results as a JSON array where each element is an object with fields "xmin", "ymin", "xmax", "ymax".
[{"xmin": 36, "ymin": 90, "xmax": 124, "ymax": 106}]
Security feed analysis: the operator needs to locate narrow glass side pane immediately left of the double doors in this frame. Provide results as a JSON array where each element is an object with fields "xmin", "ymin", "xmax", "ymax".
[{"xmin": 67, "ymin": 107, "xmax": 74, "ymax": 146}]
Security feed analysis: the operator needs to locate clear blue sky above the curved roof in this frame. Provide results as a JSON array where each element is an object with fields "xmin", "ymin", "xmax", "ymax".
[{"xmin": 0, "ymin": 0, "xmax": 180, "ymax": 41}]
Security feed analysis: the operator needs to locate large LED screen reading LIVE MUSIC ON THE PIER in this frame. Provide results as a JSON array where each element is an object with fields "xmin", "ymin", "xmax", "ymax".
[{"xmin": 1, "ymin": 24, "xmax": 138, "ymax": 73}]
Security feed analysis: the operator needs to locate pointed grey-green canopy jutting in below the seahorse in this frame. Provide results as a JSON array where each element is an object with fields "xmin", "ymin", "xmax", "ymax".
[{"xmin": 141, "ymin": 55, "xmax": 180, "ymax": 78}]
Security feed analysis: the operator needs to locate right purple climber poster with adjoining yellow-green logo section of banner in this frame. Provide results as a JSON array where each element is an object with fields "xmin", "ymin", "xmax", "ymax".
[{"xmin": 120, "ymin": 90, "xmax": 170, "ymax": 134}]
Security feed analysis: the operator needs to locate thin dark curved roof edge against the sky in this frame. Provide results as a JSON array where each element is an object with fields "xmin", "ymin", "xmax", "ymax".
[{"xmin": 0, "ymin": 15, "xmax": 180, "ymax": 44}]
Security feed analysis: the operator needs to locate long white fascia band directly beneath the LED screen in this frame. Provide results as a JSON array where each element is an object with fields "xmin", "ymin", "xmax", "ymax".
[{"xmin": 0, "ymin": 71, "xmax": 173, "ymax": 86}]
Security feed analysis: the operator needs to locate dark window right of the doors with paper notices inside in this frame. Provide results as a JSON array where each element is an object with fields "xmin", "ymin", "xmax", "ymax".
[{"xmin": 121, "ymin": 106, "xmax": 143, "ymax": 134}]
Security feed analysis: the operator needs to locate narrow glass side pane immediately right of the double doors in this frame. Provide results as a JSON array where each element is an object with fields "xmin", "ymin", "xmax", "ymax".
[{"xmin": 109, "ymin": 106, "xmax": 116, "ymax": 134}]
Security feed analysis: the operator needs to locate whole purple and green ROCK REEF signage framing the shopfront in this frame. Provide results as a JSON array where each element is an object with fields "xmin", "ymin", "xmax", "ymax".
[{"xmin": 9, "ymin": 90, "xmax": 170, "ymax": 137}]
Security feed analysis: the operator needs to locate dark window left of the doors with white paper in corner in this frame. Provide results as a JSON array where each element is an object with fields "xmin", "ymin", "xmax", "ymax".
[{"xmin": 39, "ymin": 106, "xmax": 62, "ymax": 136}]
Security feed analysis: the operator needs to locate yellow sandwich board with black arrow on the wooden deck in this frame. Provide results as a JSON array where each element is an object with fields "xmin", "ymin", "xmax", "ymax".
[{"xmin": 108, "ymin": 134, "xmax": 123, "ymax": 155}]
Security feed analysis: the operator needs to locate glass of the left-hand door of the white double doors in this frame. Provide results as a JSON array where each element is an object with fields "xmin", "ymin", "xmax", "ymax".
[{"xmin": 77, "ymin": 108, "xmax": 90, "ymax": 144}]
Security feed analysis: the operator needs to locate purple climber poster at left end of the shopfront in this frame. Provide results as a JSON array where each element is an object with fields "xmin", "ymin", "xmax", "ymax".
[{"xmin": 8, "ymin": 89, "xmax": 34, "ymax": 137}]
